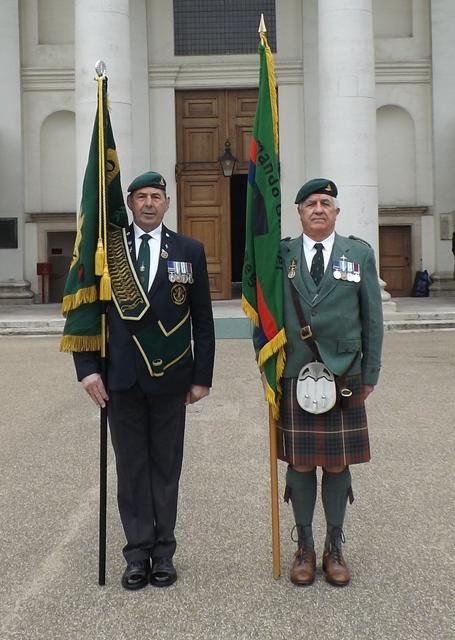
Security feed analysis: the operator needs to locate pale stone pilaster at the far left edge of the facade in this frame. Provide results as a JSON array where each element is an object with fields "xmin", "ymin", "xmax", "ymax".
[{"xmin": 0, "ymin": 0, "xmax": 33, "ymax": 304}]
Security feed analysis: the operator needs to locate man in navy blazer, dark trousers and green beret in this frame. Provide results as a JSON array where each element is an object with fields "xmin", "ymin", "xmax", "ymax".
[{"xmin": 73, "ymin": 171, "xmax": 215, "ymax": 589}]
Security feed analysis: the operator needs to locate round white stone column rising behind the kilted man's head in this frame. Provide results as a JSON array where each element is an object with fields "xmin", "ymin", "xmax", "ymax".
[{"xmin": 318, "ymin": 0, "xmax": 378, "ymax": 252}]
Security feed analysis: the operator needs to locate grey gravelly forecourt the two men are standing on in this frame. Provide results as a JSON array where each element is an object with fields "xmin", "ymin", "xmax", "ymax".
[{"xmin": 0, "ymin": 330, "xmax": 455, "ymax": 640}]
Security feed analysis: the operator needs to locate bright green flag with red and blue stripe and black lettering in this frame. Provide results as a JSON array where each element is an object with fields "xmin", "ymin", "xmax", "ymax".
[{"xmin": 242, "ymin": 32, "xmax": 286, "ymax": 418}]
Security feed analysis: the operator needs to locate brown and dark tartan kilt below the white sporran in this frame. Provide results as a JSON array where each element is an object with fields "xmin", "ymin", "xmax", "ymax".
[{"xmin": 277, "ymin": 375, "xmax": 370, "ymax": 467}]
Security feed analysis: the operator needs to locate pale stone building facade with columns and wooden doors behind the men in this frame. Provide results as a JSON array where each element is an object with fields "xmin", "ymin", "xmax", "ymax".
[{"xmin": 0, "ymin": 0, "xmax": 455, "ymax": 304}]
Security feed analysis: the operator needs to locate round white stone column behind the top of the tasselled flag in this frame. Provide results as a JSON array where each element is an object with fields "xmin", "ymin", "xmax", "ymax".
[{"xmin": 75, "ymin": 0, "xmax": 132, "ymax": 205}]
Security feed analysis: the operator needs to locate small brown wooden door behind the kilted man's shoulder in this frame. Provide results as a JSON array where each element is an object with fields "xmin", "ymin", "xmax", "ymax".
[{"xmin": 379, "ymin": 225, "xmax": 412, "ymax": 298}]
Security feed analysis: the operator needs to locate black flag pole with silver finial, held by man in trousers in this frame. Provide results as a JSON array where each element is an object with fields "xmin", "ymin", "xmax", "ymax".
[{"xmin": 95, "ymin": 60, "xmax": 107, "ymax": 586}]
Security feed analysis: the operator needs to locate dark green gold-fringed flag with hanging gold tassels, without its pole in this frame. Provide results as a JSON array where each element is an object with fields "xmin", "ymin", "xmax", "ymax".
[{"xmin": 60, "ymin": 76, "xmax": 128, "ymax": 351}]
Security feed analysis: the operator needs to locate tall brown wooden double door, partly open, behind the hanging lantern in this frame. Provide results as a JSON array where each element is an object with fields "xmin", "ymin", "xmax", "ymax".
[{"xmin": 176, "ymin": 89, "xmax": 257, "ymax": 300}]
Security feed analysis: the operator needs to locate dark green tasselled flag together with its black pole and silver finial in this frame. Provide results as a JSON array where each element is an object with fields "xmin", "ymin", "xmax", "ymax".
[{"xmin": 60, "ymin": 60, "xmax": 128, "ymax": 585}]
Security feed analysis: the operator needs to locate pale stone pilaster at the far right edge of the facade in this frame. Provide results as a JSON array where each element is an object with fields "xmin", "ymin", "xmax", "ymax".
[{"xmin": 430, "ymin": 0, "xmax": 455, "ymax": 296}]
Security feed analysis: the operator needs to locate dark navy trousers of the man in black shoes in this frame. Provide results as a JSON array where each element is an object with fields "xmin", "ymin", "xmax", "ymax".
[{"xmin": 108, "ymin": 384, "xmax": 186, "ymax": 562}]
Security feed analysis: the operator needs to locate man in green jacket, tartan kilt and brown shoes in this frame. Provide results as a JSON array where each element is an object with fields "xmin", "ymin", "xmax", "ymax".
[{"xmin": 278, "ymin": 178, "xmax": 383, "ymax": 586}]
